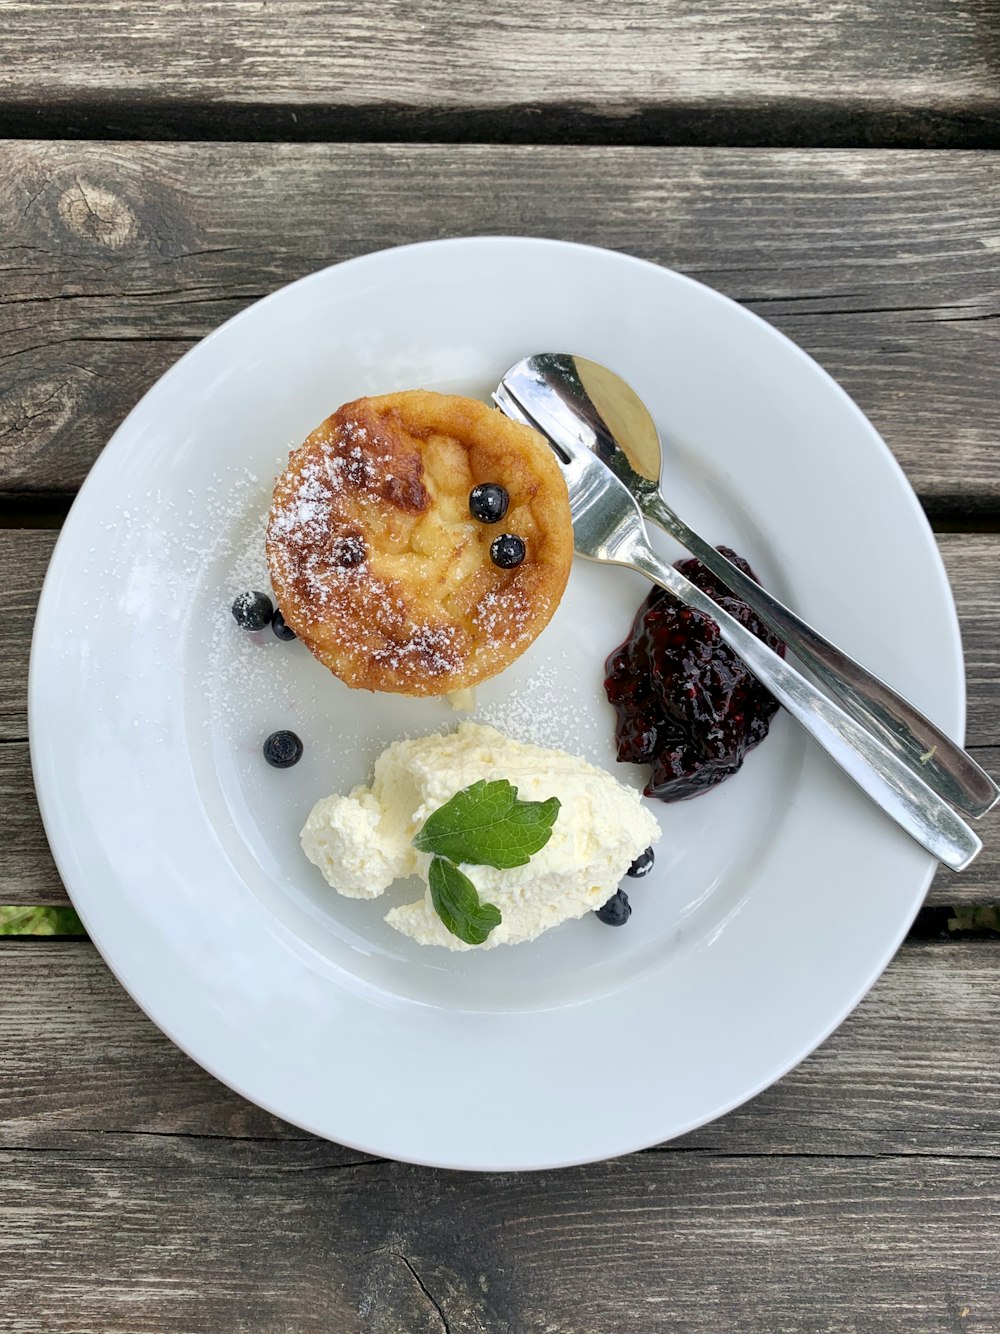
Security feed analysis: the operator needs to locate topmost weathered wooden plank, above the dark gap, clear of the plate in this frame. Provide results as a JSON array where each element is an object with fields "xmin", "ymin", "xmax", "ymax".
[{"xmin": 0, "ymin": 0, "xmax": 1000, "ymax": 143}]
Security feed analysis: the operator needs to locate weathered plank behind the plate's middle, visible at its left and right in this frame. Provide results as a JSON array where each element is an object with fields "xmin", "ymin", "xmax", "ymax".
[{"xmin": 0, "ymin": 528, "xmax": 1000, "ymax": 904}]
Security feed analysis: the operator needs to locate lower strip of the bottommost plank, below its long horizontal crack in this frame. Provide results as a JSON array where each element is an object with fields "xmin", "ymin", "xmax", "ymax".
[{"xmin": 0, "ymin": 1141, "xmax": 1000, "ymax": 1334}]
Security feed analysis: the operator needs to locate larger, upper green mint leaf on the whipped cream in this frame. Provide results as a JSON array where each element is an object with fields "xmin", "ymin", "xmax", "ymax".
[{"xmin": 413, "ymin": 778, "xmax": 559, "ymax": 871}]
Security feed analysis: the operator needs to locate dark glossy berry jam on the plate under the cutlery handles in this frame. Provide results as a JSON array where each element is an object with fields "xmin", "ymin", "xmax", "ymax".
[{"xmin": 604, "ymin": 547, "xmax": 785, "ymax": 802}]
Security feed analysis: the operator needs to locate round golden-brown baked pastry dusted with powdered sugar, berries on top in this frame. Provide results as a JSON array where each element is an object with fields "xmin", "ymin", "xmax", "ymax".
[{"xmin": 267, "ymin": 390, "xmax": 573, "ymax": 695}]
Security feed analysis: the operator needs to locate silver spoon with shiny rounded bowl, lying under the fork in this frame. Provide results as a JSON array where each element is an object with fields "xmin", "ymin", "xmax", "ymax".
[{"xmin": 493, "ymin": 352, "xmax": 1000, "ymax": 819}]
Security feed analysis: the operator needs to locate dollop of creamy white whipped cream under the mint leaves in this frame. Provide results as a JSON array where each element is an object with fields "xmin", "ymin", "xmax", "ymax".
[{"xmin": 301, "ymin": 722, "xmax": 660, "ymax": 950}]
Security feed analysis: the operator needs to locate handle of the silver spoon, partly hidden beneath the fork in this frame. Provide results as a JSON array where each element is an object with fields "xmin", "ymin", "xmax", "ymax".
[{"xmin": 633, "ymin": 487, "xmax": 1000, "ymax": 819}]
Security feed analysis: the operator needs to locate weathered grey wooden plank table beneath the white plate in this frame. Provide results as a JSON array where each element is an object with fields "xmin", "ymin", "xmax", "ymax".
[{"xmin": 0, "ymin": 0, "xmax": 1000, "ymax": 1334}]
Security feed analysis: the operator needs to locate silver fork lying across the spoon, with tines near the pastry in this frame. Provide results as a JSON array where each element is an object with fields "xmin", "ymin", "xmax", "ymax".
[{"xmin": 495, "ymin": 383, "xmax": 983, "ymax": 871}]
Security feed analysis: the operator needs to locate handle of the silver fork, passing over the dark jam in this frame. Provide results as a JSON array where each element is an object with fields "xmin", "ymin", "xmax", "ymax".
[{"xmin": 629, "ymin": 539, "xmax": 983, "ymax": 871}]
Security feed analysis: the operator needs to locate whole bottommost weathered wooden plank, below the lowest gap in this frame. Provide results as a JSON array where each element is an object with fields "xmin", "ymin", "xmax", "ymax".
[{"xmin": 0, "ymin": 943, "xmax": 1000, "ymax": 1334}]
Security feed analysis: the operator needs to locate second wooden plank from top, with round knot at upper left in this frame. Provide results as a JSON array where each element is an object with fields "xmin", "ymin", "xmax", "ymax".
[{"xmin": 0, "ymin": 140, "xmax": 1000, "ymax": 504}]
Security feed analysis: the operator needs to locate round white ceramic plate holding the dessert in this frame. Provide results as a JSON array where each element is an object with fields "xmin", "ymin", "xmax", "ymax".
[{"xmin": 31, "ymin": 237, "xmax": 964, "ymax": 1169}]
